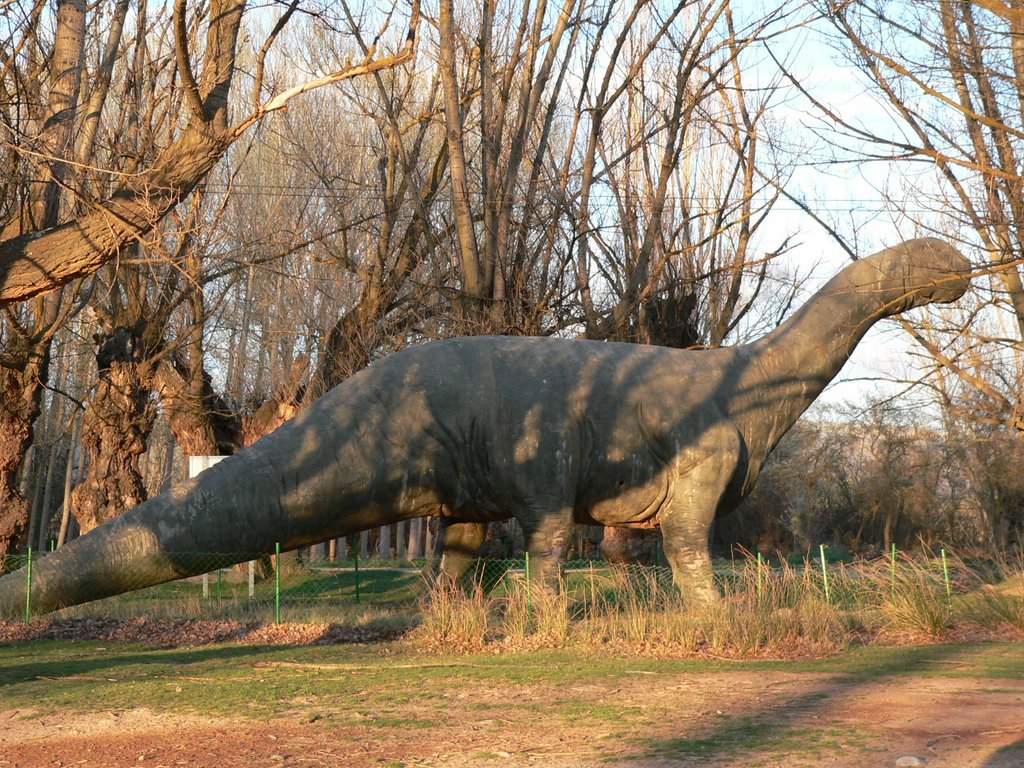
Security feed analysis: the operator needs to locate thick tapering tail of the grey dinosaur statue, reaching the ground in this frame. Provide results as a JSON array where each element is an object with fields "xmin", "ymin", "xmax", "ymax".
[{"xmin": 0, "ymin": 403, "xmax": 399, "ymax": 618}]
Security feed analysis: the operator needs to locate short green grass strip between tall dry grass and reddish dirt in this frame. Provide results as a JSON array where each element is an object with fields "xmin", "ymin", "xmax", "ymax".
[{"xmin": 0, "ymin": 641, "xmax": 1024, "ymax": 720}]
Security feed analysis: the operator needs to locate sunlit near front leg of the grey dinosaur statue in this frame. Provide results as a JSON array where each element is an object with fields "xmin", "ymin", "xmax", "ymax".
[{"xmin": 658, "ymin": 425, "xmax": 740, "ymax": 608}]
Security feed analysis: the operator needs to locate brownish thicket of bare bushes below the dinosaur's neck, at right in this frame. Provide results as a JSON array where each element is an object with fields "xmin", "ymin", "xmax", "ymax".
[{"xmin": 714, "ymin": 399, "xmax": 1024, "ymax": 557}]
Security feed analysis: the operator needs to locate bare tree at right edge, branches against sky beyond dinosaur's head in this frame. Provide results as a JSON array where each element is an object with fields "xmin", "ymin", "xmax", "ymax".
[{"xmin": 794, "ymin": 0, "xmax": 1024, "ymax": 548}]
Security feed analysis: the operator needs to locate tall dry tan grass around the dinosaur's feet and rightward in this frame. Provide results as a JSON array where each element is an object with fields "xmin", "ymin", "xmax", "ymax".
[{"xmin": 414, "ymin": 557, "xmax": 1024, "ymax": 656}]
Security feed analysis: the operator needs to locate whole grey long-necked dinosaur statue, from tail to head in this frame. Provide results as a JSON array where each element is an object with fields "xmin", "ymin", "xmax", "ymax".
[{"xmin": 0, "ymin": 239, "xmax": 970, "ymax": 616}]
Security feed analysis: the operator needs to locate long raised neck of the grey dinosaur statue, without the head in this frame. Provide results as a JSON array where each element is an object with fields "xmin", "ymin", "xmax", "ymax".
[{"xmin": 733, "ymin": 259, "xmax": 910, "ymax": 466}]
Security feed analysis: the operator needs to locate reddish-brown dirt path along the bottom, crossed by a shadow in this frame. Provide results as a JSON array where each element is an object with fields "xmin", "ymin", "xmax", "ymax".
[{"xmin": 6, "ymin": 671, "xmax": 1024, "ymax": 768}]
